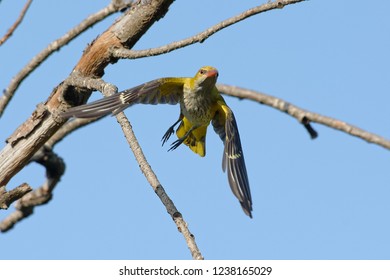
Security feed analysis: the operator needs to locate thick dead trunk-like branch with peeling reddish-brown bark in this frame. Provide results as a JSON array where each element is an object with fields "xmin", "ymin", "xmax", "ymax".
[{"xmin": 0, "ymin": 0, "xmax": 172, "ymax": 186}]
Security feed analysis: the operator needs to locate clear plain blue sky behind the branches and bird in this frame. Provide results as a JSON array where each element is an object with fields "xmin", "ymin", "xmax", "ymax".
[{"xmin": 0, "ymin": 0, "xmax": 390, "ymax": 259}]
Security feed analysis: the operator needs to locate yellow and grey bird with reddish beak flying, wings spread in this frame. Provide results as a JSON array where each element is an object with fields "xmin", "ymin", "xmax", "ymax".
[{"xmin": 61, "ymin": 66, "xmax": 253, "ymax": 218}]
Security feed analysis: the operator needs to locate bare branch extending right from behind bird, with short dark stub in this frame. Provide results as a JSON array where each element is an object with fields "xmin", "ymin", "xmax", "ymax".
[{"xmin": 217, "ymin": 84, "xmax": 390, "ymax": 150}]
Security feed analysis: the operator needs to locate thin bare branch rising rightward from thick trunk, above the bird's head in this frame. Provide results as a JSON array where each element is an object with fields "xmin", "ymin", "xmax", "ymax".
[{"xmin": 112, "ymin": 0, "xmax": 305, "ymax": 59}]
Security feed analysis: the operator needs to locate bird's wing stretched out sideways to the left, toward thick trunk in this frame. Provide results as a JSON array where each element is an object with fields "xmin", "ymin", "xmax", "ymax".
[{"xmin": 62, "ymin": 78, "xmax": 188, "ymax": 118}]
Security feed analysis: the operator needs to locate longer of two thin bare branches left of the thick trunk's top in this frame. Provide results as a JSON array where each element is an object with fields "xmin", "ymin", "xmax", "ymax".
[{"xmin": 0, "ymin": 0, "xmax": 132, "ymax": 117}]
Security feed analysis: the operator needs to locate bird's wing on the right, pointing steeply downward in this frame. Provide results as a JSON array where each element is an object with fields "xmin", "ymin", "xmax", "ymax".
[{"xmin": 212, "ymin": 99, "xmax": 252, "ymax": 218}]
